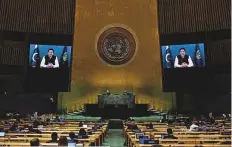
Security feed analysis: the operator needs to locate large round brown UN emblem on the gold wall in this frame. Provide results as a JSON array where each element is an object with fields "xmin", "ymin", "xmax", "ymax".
[{"xmin": 97, "ymin": 27, "xmax": 136, "ymax": 66}]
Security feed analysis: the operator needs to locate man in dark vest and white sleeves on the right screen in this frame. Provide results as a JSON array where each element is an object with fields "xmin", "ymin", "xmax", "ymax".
[{"xmin": 174, "ymin": 48, "xmax": 193, "ymax": 68}]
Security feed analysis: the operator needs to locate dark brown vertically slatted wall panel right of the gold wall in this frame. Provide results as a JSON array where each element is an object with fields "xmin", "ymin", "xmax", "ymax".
[{"xmin": 158, "ymin": 0, "xmax": 231, "ymax": 35}]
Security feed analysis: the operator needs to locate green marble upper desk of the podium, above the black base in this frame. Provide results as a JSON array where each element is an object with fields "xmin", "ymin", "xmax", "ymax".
[{"xmin": 98, "ymin": 93, "xmax": 135, "ymax": 108}]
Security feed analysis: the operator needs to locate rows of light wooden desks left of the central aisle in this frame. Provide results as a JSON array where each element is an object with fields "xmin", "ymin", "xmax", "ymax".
[{"xmin": 0, "ymin": 122, "xmax": 108, "ymax": 146}]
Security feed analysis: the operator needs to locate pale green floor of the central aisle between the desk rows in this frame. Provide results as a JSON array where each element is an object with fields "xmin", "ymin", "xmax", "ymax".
[{"xmin": 102, "ymin": 129, "xmax": 125, "ymax": 147}]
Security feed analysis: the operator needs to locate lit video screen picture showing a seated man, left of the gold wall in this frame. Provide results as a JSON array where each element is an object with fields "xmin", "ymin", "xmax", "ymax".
[{"xmin": 29, "ymin": 44, "xmax": 72, "ymax": 68}]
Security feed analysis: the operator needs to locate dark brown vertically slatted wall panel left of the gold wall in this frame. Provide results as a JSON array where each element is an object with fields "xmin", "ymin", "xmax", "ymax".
[{"xmin": 0, "ymin": 0, "xmax": 75, "ymax": 34}]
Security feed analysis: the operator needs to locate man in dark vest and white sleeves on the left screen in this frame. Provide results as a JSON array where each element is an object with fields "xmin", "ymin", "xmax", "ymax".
[{"xmin": 40, "ymin": 48, "xmax": 59, "ymax": 68}]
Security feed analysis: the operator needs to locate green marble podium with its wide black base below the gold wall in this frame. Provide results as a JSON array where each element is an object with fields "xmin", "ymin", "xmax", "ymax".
[{"xmin": 84, "ymin": 92, "xmax": 149, "ymax": 119}]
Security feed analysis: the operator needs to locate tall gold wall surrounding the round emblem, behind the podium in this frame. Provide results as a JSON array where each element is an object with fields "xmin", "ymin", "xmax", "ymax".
[{"xmin": 59, "ymin": 0, "xmax": 175, "ymax": 111}]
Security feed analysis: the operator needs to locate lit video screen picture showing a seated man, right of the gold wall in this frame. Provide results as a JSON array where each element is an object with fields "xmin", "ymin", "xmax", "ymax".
[{"xmin": 161, "ymin": 43, "xmax": 205, "ymax": 68}]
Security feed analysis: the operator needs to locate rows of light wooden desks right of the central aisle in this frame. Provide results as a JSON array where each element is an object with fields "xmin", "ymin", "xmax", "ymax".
[{"xmin": 124, "ymin": 122, "xmax": 231, "ymax": 147}]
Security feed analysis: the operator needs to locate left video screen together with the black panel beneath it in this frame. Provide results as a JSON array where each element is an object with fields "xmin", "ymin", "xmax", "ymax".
[{"xmin": 26, "ymin": 44, "xmax": 72, "ymax": 92}]
